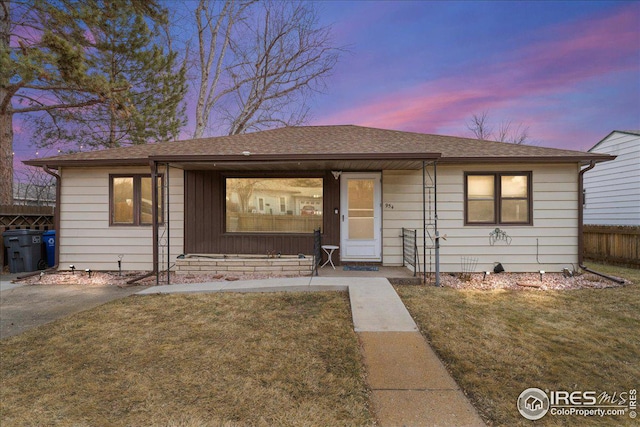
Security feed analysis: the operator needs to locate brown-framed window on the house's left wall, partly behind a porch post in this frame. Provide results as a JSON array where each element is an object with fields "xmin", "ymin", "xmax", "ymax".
[{"xmin": 109, "ymin": 175, "xmax": 164, "ymax": 225}]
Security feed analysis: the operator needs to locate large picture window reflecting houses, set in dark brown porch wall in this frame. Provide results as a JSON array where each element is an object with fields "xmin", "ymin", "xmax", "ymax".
[{"xmin": 225, "ymin": 178, "xmax": 323, "ymax": 233}]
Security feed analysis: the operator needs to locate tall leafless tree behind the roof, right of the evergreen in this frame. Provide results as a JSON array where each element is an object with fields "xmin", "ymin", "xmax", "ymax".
[{"xmin": 194, "ymin": 0, "xmax": 340, "ymax": 138}]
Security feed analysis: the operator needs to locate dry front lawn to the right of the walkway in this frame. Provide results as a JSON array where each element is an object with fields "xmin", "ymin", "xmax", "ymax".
[{"xmin": 396, "ymin": 265, "xmax": 640, "ymax": 426}]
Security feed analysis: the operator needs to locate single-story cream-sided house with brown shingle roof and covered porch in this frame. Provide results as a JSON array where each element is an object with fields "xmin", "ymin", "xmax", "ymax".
[{"xmin": 25, "ymin": 125, "xmax": 613, "ymax": 272}]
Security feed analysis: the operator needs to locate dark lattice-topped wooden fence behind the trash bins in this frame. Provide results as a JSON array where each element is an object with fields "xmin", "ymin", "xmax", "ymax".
[{"xmin": 0, "ymin": 205, "xmax": 54, "ymax": 269}]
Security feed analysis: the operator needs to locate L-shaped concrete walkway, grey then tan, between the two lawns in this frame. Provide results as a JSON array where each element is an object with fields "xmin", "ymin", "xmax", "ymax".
[{"xmin": 138, "ymin": 277, "xmax": 485, "ymax": 427}]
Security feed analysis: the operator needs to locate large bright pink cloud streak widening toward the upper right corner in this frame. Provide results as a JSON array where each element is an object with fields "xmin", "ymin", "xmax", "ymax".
[{"xmin": 317, "ymin": 5, "xmax": 640, "ymax": 140}]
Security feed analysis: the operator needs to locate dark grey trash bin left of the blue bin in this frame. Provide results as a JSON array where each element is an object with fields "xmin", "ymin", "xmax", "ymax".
[{"xmin": 2, "ymin": 230, "xmax": 47, "ymax": 273}]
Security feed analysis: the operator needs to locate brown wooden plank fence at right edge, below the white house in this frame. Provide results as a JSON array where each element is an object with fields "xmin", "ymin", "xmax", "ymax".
[{"xmin": 583, "ymin": 225, "xmax": 640, "ymax": 268}]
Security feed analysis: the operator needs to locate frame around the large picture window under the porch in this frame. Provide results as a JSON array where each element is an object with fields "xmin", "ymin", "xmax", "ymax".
[{"xmin": 220, "ymin": 172, "xmax": 327, "ymax": 236}]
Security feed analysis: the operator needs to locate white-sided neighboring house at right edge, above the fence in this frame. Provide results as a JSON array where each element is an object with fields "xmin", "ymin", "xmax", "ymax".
[{"xmin": 584, "ymin": 130, "xmax": 640, "ymax": 226}]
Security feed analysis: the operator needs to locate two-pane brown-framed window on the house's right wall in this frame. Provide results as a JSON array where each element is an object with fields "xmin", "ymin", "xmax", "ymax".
[{"xmin": 465, "ymin": 172, "xmax": 532, "ymax": 225}]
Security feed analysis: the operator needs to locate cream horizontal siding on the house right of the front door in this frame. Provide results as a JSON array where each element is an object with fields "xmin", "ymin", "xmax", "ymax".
[{"xmin": 383, "ymin": 163, "xmax": 579, "ymax": 272}]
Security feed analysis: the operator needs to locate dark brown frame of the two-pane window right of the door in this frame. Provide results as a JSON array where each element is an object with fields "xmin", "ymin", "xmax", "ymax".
[{"xmin": 464, "ymin": 171, "xmax": 533, "ymax": 227}]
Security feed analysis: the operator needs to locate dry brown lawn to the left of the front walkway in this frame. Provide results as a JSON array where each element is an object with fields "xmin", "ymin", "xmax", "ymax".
[{"xmin": 0, "ymin": 293, "xmax": 374, "ymax": 427}]
